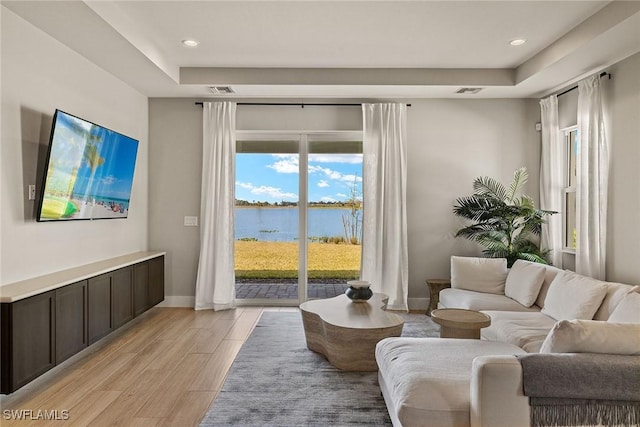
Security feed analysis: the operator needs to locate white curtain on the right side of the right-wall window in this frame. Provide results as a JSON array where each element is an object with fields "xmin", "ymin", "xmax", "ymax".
[{"xmin": 576, "ymin": 75, "xmax": 609, "ymax": 280}]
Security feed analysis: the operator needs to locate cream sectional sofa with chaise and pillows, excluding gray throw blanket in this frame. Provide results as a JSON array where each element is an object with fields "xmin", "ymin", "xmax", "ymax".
[{"xmin": 376, "ymin": 257, "xmax": 640, "ymax": 427}]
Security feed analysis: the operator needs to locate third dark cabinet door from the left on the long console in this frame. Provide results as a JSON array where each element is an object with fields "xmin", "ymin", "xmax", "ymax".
[{"xmin": 87, "ymin": 273, "xmax": 113, "ymax": 344}]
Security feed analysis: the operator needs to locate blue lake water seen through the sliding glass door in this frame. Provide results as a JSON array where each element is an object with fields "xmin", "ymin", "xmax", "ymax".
[{"xmin": 235, "ymin": 207, "xmax": 358, "ymax": 242}]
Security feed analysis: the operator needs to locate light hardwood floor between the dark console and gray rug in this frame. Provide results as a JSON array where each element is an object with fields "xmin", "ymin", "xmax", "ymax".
[{"xmin": 0, "ymin": 307, "xmax": 296, "ymax": 427}]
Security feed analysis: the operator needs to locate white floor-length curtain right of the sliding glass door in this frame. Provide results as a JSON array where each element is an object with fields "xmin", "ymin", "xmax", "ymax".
[{"xmin": 361, "ymin": 104, "xmax": 409, "ymax": 310}]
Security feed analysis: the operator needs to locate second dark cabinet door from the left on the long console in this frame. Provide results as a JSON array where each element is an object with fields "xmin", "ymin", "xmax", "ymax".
[{"xmin": 56, "ymin": 280, "xmax": 88, "ymax": 363}]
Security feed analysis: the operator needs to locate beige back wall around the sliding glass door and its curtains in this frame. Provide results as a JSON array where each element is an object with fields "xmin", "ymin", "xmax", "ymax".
[{"xmin": 149, "ymin": 99, "xmax": 540, "ymax": 301}]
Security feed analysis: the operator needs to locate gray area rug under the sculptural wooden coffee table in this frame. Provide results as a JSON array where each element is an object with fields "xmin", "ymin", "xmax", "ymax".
[{"xmin": 200, "ymin": 312, "xmax": 439, "ymax": 427}]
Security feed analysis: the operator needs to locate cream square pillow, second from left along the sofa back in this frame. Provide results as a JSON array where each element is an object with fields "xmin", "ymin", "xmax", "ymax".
[{"xmin": 504, "ymin": 259, "xmax": 546, "ymax": 307}]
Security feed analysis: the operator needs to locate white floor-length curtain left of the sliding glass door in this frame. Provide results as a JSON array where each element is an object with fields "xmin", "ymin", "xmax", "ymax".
[{"xmin": 195, "ymin": 102, "xmax": 236, "ymax": 310}]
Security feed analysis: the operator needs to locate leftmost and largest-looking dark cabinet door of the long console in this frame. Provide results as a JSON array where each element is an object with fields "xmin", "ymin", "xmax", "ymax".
[{"xmin": 9, "ymin": 291, "xmax": 56, "ymax": 390}]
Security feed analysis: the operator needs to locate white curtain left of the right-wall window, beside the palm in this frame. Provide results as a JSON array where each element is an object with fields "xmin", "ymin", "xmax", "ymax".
[{"xmin": 540, "ymin": 95, "xmax": 564, "ymax": 268}]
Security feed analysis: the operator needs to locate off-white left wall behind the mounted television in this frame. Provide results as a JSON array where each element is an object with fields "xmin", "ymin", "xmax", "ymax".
[{"xmin": 0, "ymin": 7, "xmax": 148, "ymax": 285}]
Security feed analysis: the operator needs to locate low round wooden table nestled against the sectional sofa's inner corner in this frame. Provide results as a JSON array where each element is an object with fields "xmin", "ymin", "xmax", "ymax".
[{"xmin": 431, "ymin": 308, "xmax": 491, "ymax": 339}]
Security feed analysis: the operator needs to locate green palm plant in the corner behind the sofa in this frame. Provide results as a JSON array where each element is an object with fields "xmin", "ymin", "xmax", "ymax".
[{"xmin": 453, "ymin": 168, "xmax": 556, "ymax": 267}]
